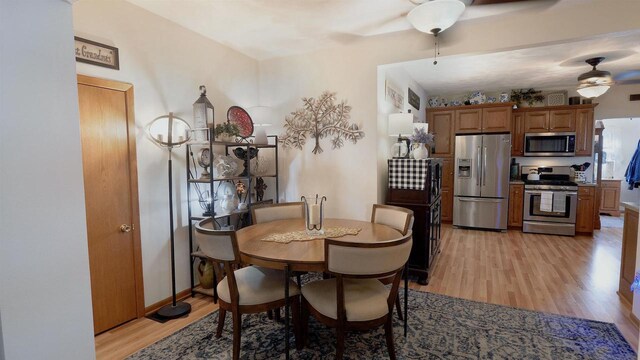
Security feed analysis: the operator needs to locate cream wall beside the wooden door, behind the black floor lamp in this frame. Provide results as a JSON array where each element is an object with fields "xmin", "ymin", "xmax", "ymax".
[{"xmin": 73, "ymin": 0, "xmax": 258, "ymax": 306}]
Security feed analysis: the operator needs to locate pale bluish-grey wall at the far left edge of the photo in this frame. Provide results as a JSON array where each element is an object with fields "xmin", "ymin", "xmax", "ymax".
[{"xmin": 0, "ymin": 0, "xmax": 95, "ymax": 359}]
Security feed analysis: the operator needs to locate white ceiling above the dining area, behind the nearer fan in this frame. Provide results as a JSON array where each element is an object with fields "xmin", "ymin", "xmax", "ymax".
[{"xmin": 128, "ymin": 0, "xmax": 564, "ymax": 60}]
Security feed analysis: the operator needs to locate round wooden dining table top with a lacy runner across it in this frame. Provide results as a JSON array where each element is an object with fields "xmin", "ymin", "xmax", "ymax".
[{"xmin": 236, "ymin": 219, "xmax": 402, "ymax": 272}]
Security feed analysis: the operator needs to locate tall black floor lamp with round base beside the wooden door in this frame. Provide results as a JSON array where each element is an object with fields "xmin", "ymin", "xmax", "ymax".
[{"xmin": 147, "ymin": 113, "xmax": 191, "ymax": 319}]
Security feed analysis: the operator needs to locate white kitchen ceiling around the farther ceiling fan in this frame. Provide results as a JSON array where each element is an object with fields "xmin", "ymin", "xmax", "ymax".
[{"xmin": 396, "ymin": 31, "xmax": 640, "ymax": 95}]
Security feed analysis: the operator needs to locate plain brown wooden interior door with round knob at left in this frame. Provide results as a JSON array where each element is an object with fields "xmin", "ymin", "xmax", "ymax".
[{"xmin": 78, "ymin": 76, "xmax": 144, "ymax": 334}]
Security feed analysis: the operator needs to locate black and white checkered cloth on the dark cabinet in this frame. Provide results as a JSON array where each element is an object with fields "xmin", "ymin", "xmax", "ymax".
[{"xmin": 388, "ymin": 159, "xmax": 429, "ymax": 190}]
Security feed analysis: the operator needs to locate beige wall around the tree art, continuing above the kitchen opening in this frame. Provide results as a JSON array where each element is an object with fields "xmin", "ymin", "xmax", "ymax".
[{"xmin": 260, "ymin": 0, "xmax": 640, "ymax": 214}]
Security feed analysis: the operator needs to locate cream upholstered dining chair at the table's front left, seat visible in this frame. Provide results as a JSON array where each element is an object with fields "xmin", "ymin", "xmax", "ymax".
[{"xmin": 196, "ymin": 218, "xmax": 301, "ymax": 360}]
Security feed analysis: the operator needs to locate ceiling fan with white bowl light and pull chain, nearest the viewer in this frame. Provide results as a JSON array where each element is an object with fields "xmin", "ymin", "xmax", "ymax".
[{"xmin": 407, "ymin": 0, "xmax": 552, "ymax": 65}]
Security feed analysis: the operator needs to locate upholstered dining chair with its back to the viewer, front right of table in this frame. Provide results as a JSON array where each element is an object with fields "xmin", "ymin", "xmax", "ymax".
[{"xmin": 301, "ymin": 231, "xmax": 412, "ymax": 359}]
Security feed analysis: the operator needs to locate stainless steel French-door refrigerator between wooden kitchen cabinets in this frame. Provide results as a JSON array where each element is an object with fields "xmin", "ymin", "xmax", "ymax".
[{"xmin": 453, "ymin": 134, "xmax": 511, "ymax": 230}]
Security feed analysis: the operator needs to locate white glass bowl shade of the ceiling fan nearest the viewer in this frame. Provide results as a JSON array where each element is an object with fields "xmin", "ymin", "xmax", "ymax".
[{"xmin": 407, "ymin": 0, "xmax": 465, "ymax": 35}]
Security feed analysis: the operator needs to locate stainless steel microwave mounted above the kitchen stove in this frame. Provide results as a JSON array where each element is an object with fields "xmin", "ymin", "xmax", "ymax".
[{"xmin": 524, "ymin": 132, "xmax": 576, "ymax": 156}]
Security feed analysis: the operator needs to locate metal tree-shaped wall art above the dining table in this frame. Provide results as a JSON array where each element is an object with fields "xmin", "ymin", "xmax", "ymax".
[{"xmin": 281, "ymin": 91, "xmax": 364, "ymax": 154}]
